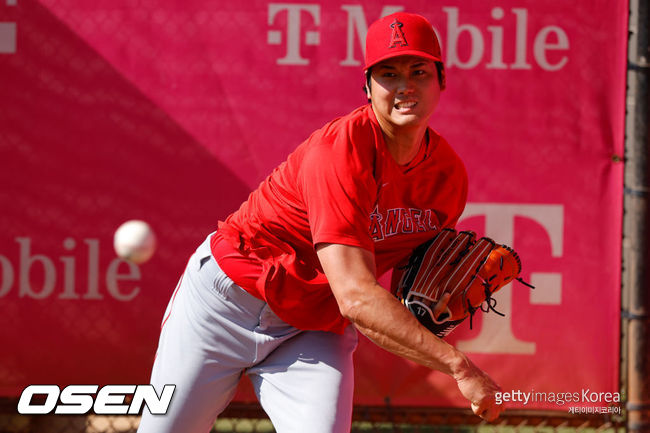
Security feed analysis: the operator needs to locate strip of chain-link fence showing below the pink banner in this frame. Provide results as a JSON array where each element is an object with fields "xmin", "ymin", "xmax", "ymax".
[{"xmin": 0, "ymin": 400, "xmax": 626, "ymax": 433}]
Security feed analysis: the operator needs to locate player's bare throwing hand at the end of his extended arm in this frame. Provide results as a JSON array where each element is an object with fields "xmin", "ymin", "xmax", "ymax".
[{"xmin": 454, "ymin": 358, "xmax": 505, "ymax": 421}]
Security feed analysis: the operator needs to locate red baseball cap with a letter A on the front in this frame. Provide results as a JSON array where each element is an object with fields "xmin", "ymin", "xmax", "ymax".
[{"xmin": 364, "ymin": 12, "xmax": 442, "ymax": 70}]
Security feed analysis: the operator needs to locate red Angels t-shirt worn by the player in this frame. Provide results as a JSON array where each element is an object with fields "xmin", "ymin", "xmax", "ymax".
[{"xmin": 211, "ymin": 105, "xmax": 467, "ymax": 333}]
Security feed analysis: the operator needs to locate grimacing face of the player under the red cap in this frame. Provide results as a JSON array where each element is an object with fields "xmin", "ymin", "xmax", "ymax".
[{"xmin": 368, "ymin": 56, "xmax": 440, "ymax": 131}]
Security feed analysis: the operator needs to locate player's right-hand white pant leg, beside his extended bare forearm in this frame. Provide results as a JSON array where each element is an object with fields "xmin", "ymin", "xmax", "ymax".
[{"xmin": 247, "ymin": 325, "xmax": 357, "ymax": 433}]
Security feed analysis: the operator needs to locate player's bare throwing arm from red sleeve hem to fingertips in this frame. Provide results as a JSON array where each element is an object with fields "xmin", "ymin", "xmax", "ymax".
[{"xmin": 316, "ymin": 244, "xmax": 503, "ymax": 420}]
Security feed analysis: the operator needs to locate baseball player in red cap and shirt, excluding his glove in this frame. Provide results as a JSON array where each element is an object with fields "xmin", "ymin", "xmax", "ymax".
[{"xmin": 138, "ymin": 12, "xmax": 502, "ymax": 433}]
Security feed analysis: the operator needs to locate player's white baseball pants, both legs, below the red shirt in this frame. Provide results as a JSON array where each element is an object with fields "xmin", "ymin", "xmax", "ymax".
[{"xmin": 138, "ymin": 236, "xmax": 357, "ymax": 433}]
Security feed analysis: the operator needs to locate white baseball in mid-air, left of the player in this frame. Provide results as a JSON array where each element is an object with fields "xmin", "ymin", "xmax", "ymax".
[{"xmin": 113, "ymin": 220, "xmax": 156, "ymax": 264}]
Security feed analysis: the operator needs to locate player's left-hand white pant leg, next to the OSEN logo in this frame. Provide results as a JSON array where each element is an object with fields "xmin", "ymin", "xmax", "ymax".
[{"xmin": 138, "ymin": 236, "xmax": 299, "ymax": 433}]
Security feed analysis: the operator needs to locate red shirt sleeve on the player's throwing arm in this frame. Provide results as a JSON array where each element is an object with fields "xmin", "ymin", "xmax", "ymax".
[{"xmin": 298, "ymin": 120, "xmax": 377, "ymax": 252}]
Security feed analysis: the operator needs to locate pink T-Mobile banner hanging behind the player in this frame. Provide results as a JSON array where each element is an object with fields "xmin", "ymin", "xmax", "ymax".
[{"xmin": 0, "ymin": 0, "xmax": 628, "ymax": 410}]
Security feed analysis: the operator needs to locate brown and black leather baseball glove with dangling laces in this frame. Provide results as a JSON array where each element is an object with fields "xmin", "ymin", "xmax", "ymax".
[{"xmin": 397, "ymin": 229, "xmax": 534, "ymax": 338}]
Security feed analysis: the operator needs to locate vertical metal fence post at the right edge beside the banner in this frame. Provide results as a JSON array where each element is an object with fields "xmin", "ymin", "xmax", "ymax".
[{"xmin": 622, "ymin": 0, "xmax": 650, "ymax": 433}]
